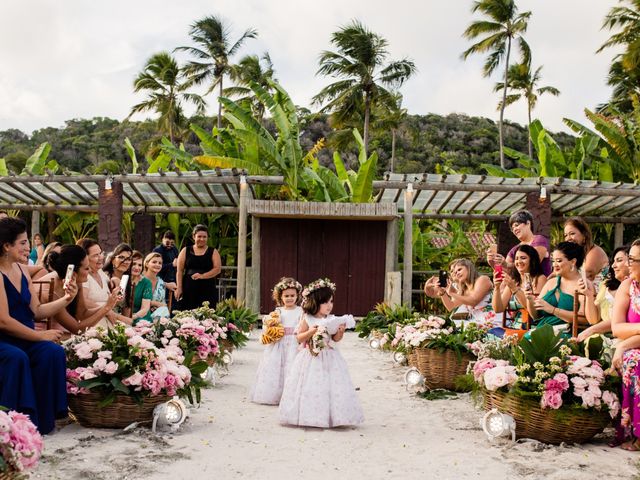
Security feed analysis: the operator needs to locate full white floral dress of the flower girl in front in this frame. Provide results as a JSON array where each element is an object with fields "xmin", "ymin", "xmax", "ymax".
[{"xmin": 279, "ymin": 315, "xmax": 364, "ymax": 428}]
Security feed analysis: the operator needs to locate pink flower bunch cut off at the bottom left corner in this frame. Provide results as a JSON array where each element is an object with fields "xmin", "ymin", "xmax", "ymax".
[{"xmin": 0, "ymin": 410, "xmax": 43, "ymax": 478}]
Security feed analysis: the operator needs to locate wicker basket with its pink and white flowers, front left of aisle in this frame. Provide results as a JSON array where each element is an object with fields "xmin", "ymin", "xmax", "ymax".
[{"xmin": 64, "ymin": 322, "xmax": 192, "ymax": 427}]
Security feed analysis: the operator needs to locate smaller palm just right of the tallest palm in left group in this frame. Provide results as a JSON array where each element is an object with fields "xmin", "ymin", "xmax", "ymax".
[{"xmin": 223, "ymin": 52, "xmax": 276, "ymax": 122}]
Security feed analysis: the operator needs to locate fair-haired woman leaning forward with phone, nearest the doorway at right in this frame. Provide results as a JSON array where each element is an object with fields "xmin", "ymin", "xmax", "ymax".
[{"xmin": 424, "ymin": 258, "xmax": 502, "ymax": 326}]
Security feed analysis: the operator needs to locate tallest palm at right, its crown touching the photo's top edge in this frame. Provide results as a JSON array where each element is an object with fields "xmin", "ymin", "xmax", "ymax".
[{"xmin": 462, "ymin": 0, "xmax": 531, "ymax": 168}]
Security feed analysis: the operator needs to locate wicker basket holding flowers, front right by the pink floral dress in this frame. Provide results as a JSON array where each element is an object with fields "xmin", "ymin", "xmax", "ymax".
[{"xmin": 483, "ymin": 391, "xmax": 611, "ymax": 445}]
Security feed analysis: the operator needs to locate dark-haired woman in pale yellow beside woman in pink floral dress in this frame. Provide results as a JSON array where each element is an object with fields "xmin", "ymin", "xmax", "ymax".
[{"xmin": 578, "ymin": 246, "xmax": 629, "ymax": 342}]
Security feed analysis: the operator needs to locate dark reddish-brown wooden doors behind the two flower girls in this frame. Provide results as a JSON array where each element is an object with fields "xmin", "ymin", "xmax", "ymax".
[{"xmin": 260, "ymin": 218, "xmax": 387, "ymax": 315}]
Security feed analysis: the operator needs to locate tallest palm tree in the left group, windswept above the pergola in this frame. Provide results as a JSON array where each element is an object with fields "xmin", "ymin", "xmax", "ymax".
[{"xmin": 175, "ymin": 15, "xmax": 258, "ymax": 129}]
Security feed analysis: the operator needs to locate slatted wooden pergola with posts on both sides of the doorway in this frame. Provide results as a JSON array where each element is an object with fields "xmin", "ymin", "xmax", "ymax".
[{"xmin": 0, "ymin": 169, "xmax": 640, "ymax": 308}]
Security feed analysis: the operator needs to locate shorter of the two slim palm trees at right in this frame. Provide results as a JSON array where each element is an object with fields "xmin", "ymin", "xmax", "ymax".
[{"xmin": 494, "ymin": 63, "xmax": 560, "ymax": 158}]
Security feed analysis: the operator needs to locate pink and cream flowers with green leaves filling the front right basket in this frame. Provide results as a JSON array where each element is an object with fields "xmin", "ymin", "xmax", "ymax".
[{"xmin": 472, "ymin": 326, "xmax": 620, "ymax": 418}]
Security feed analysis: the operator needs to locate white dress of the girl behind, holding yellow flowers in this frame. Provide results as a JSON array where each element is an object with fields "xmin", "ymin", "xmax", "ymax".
[{"xmin": 249, "ymin": 307, "xmax": 302, "ymax": 405}]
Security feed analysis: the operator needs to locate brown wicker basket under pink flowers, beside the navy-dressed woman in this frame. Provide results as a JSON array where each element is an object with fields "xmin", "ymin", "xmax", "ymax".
[{"xmin": 68, "ymin": 393, "xmax": 170, "ymax": 428}]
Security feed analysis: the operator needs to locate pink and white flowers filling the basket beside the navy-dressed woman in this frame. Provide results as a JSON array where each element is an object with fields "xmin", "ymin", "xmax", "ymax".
[{"xmin": 64, "ymin": 322, "xmax": 191, "ymax": 406}]
